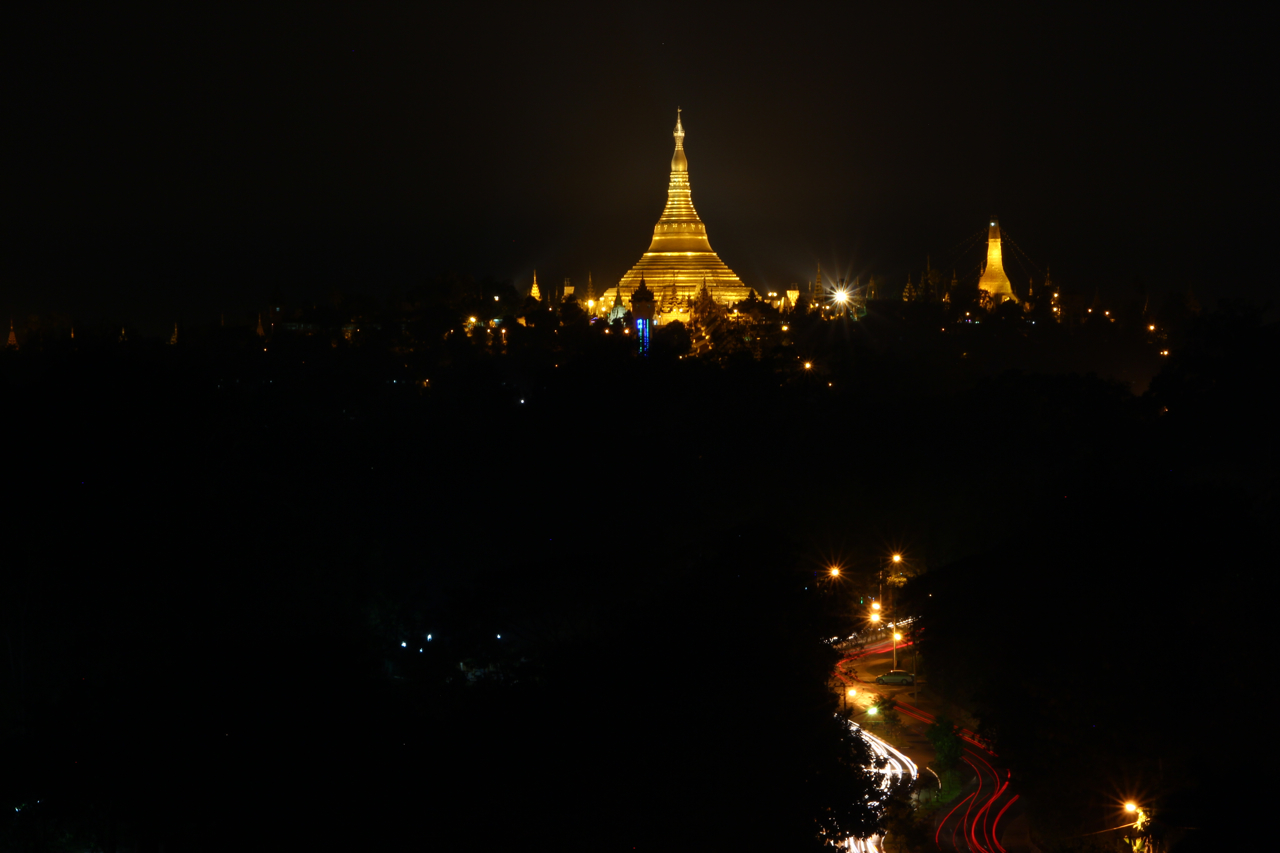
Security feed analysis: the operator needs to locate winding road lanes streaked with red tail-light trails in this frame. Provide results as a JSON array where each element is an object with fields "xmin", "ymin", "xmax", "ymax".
[{"xmin": 836, "ymin": 642, "xmax": 1029, "ymax": 853}]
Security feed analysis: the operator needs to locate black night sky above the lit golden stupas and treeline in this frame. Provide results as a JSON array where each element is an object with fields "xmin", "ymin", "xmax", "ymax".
[{"xmin": 0, "ymin": 3, "xmax": 1276, "ymax": 321}]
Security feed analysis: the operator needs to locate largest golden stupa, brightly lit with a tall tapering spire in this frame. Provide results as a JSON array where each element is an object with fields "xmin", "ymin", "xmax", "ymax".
[{"xmin": 618, "ymin": 110, "xmax": 750, "ymax": 305}]
